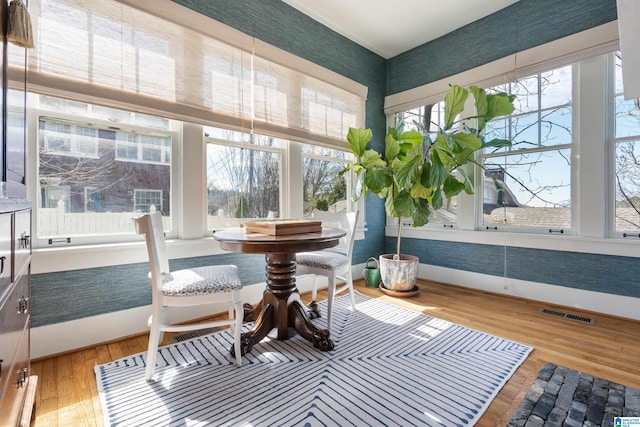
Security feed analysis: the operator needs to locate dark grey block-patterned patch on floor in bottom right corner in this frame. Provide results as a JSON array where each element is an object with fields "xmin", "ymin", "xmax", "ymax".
[{"xmin": 507, "ymin": 363, "xmax": 640, "ymax": 427}]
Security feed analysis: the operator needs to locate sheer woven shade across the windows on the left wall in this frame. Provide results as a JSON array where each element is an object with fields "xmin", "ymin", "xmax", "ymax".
[{"xmin": 28, "ymin": 0, "xmax": 367, "ymax": 148}]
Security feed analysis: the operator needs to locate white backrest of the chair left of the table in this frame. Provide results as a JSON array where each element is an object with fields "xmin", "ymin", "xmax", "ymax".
[{"xmin": 133, "ymin": 212, "xmax": 170, "ymax": 285}]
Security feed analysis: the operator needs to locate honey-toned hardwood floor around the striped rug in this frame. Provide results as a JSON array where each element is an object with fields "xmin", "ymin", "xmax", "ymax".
[{"xmin": 31, "ymin": 281, "xmax": 640, "ymax": 427}]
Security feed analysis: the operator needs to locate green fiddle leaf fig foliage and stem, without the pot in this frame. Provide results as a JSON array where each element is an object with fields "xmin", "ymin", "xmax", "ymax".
[{"xmin": 339, "ymin": 85, "xmax": 515, "ymax": 257}]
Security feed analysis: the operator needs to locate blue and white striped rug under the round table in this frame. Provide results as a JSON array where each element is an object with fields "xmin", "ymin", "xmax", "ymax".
[{"xmin": 95, "ymin": 294, "xmax": 533, "ymax": 427}]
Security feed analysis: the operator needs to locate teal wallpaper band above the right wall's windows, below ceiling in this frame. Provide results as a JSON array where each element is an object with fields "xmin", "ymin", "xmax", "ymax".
[{"xmin": 387, "ymin": 0, "xmax": 618, "ymax": 95}]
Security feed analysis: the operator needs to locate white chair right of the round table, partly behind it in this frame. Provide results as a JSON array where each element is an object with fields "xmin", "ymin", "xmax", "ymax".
[{"xmin": 296, "ymin": 211, "xmax": 358, "ymax": 329}]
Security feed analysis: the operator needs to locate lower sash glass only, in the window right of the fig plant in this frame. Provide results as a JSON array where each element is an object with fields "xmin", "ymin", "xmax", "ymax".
[{"xmin": 483, "ymin": 149, "xmax": 571, "ymax": 228}]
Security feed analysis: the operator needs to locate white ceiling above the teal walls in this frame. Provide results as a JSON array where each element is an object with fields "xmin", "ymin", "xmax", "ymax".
[{"xmin": 282, "ymin": 0, "xmax": 518, "ymax": 58}]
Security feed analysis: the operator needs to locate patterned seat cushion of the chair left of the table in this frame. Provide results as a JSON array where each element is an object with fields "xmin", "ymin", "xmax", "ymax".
[{"xmin": 162, "ymin": 265, "xmax": 242, "ymax": 296}]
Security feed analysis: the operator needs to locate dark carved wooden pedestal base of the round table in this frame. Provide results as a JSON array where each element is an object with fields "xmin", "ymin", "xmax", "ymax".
[{"xmin": 231, "ymin": 253, "xmax": 334, "ymax": 356}]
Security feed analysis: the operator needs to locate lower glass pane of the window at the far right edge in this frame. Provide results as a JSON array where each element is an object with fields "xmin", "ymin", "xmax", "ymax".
[{"xmin": 615, "ymin": 140, "xmax": 640, "ymax": 233}]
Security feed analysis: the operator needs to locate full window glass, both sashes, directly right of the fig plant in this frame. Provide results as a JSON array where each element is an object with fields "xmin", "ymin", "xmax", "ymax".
[{"xmin": 482, "ymin": 66, "xmax": 573, "ymax": 230}]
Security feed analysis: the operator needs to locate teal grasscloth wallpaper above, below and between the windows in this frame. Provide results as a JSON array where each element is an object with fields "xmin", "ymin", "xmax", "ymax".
[{"xmin": 32, "ymin": 0, "xmax": 624, "ymax": 327}]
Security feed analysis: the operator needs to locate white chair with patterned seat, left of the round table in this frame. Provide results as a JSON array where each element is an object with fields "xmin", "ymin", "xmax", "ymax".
[{"xmin": 134, "ymin": 212, "xmax": 243, "ymax": 381}]
